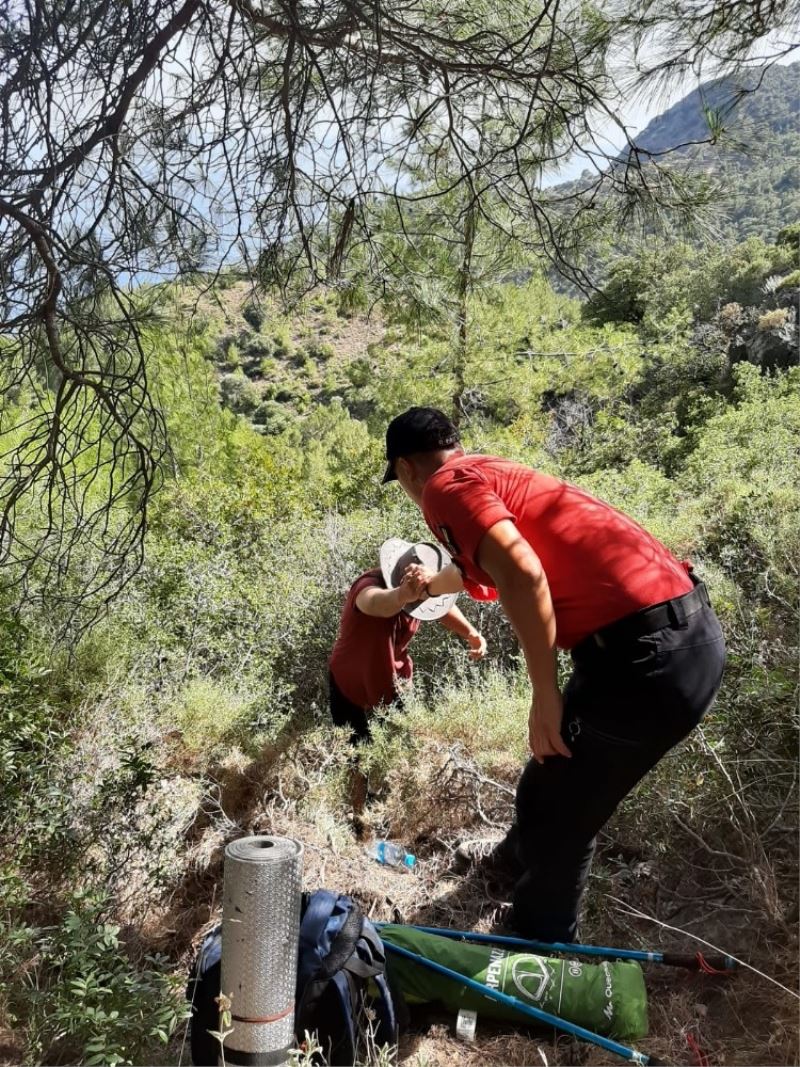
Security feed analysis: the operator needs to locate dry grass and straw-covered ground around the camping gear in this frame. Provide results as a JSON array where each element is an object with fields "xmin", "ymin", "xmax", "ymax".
[{"xmin": 149, "ymin": 736, "xmax": 798, "ymax": 1067}]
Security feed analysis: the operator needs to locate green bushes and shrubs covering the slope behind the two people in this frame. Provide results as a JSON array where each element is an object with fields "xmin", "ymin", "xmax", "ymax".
[{"xmin": 0, "ymin": 229, "xmax": 800, "ymax": 1063}]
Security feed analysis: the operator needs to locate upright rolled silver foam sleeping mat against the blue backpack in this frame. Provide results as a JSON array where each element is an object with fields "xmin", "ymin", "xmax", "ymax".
[{"xmin": 221, "ymin": 837, "xmax": 303, "ymax": 1067}]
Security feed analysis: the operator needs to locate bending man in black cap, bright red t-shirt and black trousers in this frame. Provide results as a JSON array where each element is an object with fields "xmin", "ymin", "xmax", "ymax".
[{"xmin": 384, "ymin": 408, "xmax": 724, "ymax": 941}]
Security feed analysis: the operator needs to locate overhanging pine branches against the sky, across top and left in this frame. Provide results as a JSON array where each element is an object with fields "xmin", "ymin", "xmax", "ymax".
[{"xmin": 0, "ymin": 0, "xmax": 797, "ymax": 618}]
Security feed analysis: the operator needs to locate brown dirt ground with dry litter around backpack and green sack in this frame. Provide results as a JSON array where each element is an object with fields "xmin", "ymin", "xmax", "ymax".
[{"xmin": 164, "ymin": 738, "xmax": 798, "ymax": 1067}]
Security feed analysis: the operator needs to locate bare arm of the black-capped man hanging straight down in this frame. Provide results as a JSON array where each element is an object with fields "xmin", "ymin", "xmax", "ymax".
[{"xmin": 477, "ymin": 519, "xmax": 571, "ymax": 763}]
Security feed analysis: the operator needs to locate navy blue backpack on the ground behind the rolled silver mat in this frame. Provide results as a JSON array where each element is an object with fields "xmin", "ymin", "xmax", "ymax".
[{"xmin": 187, "ymin": 889, "xmax": 404, "ymax": 1067}]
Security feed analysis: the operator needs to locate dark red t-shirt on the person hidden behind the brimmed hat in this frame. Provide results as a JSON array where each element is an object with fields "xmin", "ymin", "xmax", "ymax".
[{"xmin": 329, "ymin": 570, "xmax": 419, "ymax": 708}]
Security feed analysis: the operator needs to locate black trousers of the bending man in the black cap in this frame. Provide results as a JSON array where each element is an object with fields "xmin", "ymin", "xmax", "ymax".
[{"xmin": 503, "ymin": 602, "xmax": 725, "ymax": 941}]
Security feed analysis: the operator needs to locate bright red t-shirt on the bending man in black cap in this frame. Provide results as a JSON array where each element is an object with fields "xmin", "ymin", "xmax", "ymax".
[{"xmin": 422, "ymin": 456, "xmax": 692, "ymax": 649}]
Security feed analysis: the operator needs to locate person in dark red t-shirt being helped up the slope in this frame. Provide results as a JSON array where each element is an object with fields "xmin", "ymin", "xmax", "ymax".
[{"xmin": 329, "ymin": 569, "xmax": 486, "ymax": 819}]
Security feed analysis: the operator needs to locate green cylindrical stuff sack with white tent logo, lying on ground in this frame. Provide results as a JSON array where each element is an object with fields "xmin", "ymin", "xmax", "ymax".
[{"xmin": 380, "ymin": 925, "xmax": 647, "ymax": 1040}]
